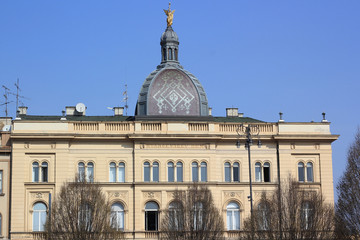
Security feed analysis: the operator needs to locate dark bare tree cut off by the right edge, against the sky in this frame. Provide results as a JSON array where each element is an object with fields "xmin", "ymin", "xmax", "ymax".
[{"xmin": 336, "ymin": 129, "xmax": 360, "ymax": 239}]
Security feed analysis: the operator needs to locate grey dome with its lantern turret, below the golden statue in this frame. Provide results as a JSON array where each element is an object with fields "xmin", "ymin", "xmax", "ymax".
[{"xmin": 135, "ymin": 21, "xmax": 209, "ymax": 117}]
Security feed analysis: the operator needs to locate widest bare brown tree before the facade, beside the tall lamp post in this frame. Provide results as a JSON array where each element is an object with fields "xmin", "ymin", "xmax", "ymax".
[{"xmin": 243, "ymin": 177, "xmax": 334, "ymax": 240}]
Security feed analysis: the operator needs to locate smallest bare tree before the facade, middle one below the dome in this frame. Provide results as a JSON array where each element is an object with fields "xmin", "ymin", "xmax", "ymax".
[{"xmin": 161, "ymin": 184, "xmax": 224, "ymax": 240}]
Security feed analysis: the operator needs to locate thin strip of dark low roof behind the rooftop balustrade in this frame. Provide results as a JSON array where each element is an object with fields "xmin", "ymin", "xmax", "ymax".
[{"xmin": 20, "ymin": 115, "xmax": 263, "ymax": 123}]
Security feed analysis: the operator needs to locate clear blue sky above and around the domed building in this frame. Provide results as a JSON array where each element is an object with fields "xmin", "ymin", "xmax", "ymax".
[{"xmin": 0, "ymin": 0, "xmax": 360, "ymax": 199}]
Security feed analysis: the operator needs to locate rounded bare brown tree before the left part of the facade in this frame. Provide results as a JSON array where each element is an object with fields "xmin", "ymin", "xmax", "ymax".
[{"xmin": 41, "ymin": 177, "xmax": 123, "ymax": 240}]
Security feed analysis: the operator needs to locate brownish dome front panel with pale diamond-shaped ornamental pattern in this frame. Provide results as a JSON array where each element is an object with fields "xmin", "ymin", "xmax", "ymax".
[{"xmin": 148, "ymin": 69, "xmax": 200, "ymax": 116}]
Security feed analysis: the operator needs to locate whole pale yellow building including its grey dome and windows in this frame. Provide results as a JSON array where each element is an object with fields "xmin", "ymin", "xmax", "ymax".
[{"xmin": 9, "ymin": 8, "xmax": 338, "ymax": 239}]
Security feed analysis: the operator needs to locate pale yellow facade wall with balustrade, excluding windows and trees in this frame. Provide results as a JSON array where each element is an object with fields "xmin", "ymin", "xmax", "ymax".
[{"xmin": 11, "ymin": 119, "xmax": 338, "ymax": 239}]
